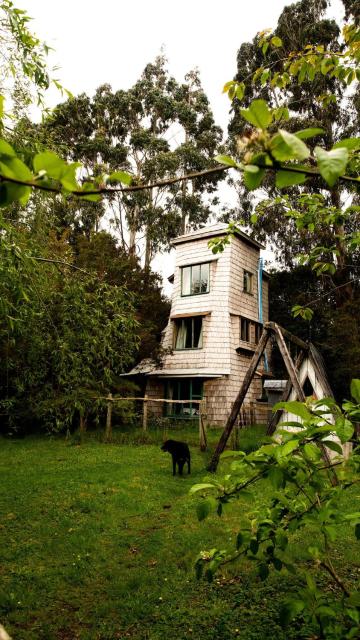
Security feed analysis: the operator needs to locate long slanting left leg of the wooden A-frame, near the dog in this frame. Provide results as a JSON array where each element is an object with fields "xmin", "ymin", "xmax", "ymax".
[{"xmin": 207, "ymin": 328, "xmax": 270, "ymax": 471}]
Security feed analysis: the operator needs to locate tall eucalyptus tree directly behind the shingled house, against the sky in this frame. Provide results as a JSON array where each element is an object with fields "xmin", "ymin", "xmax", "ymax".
[{"xmin": 42, "ymin": 56, "xmax": 222, "ymax": 267}]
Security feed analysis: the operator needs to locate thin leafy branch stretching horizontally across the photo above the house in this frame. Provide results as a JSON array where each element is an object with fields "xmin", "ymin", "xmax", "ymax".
[{"xmin": 0, "ymin": 118, "xmax": 360, "ymax": 206}]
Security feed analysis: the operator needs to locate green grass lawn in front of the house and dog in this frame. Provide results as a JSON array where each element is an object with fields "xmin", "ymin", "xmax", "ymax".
[{"xmin": 0, "ymin": 435, "xmax": 360, "ymax": 640}]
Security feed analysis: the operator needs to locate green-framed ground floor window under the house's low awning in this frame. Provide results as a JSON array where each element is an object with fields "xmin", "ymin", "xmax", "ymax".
[{"xmin": 165, "ymin": 378, "xmax": 203, "ymax": 419}]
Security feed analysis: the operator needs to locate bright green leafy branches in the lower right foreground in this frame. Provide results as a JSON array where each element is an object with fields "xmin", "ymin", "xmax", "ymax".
[{"xmin": 190, "ymin": 388, "xmax": 360, "ymax": 640}]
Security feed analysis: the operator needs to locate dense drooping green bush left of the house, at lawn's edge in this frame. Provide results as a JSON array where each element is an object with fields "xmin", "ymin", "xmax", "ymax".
[{"xmin": 0, "ymin": 218, "xmax": 138, "ymax": 431}]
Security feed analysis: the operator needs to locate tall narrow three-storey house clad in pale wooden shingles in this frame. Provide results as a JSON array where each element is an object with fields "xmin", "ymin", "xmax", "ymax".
[{"xmin": 133, "ymin": 224, "xmax": 268, "ymax": 426}]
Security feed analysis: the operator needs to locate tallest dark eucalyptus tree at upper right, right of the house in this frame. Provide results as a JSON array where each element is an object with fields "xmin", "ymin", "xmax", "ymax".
[{"xmin": 229, "ymin": 0, "xmax": 360, "ymax": 305}]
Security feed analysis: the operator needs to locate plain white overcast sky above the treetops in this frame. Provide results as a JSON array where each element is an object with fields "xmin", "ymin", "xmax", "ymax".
[{"xmin": 19, "ymin": 0, "xmax": 343, "ymax": 290}]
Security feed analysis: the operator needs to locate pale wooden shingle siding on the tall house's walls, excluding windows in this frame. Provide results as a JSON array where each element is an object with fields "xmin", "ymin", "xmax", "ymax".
[{"xmin": 148, "ymin": 224, "xmax": 268, "ymax": 426}]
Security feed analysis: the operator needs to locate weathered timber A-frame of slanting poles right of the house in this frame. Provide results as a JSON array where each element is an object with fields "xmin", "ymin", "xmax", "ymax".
[{"xmin": 207, "ymin": 322, "xmax": 333, "ymax": 471}]
